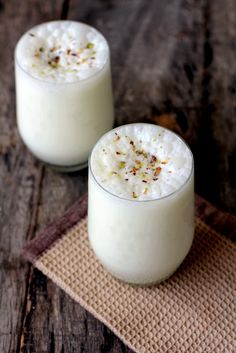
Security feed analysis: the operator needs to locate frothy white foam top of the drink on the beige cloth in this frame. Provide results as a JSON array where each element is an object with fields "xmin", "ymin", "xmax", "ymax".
[{"xmin": 91, "ymin": 124, "xmax": 193, "ymax": 200}]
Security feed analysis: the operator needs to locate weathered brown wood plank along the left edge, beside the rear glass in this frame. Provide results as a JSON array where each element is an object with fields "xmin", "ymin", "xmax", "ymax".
[{"xmin": 0, "ymin": 0, "xmax": 63, "ymax": 353}]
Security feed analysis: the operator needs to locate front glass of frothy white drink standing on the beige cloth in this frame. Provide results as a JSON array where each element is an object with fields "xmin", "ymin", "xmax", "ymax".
[{"xmin": 88, "ymin": 124, "xmax": 194, "ymax": 284}]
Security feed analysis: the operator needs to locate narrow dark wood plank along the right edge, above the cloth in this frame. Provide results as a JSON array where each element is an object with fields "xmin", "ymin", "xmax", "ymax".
[{"xmin": 208, "ymin": 0, "xmax": 236, "ymax": 213}]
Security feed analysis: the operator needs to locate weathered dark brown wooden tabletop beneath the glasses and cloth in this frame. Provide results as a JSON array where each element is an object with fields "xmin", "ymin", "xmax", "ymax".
[{"xmin": 0, "ymin": 0, "xmax": 236, "ymax": 353}]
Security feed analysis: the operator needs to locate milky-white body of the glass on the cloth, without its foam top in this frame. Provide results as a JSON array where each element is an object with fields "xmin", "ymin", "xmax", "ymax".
[{"xmin": 88, "ymin": 123, "xmax": 194, "ymax": 284}]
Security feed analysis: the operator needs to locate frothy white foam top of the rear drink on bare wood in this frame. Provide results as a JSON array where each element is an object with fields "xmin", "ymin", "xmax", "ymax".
[{"xmin": 16, "ymin": 21, "xmax": 109, "ymax": 82}]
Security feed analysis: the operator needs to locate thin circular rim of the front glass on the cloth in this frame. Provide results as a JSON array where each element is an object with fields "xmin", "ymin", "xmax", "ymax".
[{"xmin": 88, "ymin": 123, "xmax": 194, "ymax": 203}]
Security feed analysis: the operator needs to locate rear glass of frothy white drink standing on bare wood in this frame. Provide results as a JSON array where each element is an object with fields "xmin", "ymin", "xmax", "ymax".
[{"xmin": 15, "ymin": 21, "xmax": 114, "ymax": 170}]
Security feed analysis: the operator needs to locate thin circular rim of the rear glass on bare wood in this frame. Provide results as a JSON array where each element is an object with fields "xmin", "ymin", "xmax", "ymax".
[{"xmin": 14, "ymin": 20, "xmax": 110, "ymax": 86}]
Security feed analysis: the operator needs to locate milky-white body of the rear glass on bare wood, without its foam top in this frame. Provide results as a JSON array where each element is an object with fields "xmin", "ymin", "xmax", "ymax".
[{"xmin": 15, "ymin": 21, "xmax": 114, "ymax": 171}]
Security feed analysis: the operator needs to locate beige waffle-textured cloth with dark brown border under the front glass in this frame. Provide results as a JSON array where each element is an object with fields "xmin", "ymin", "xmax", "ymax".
[{"xmin": 23, "ymin": 196, "xmax": 236, "ymax": 353}]
